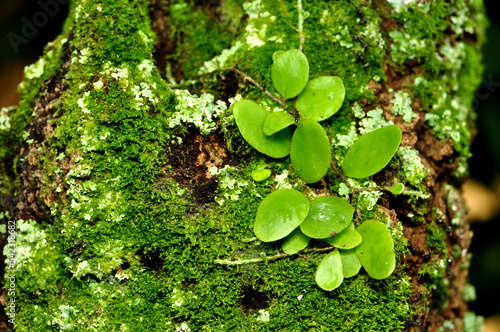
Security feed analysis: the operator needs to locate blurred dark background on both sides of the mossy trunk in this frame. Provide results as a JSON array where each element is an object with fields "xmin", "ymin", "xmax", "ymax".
[{"xmin": 0, "ymin": 0, "xmax": 500, "ymax": 331}]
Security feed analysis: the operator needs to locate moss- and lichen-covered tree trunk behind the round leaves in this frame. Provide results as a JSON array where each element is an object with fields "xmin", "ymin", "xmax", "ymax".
[{"xmin": 0, "ymin": 0, "xmax": 486, "ymax": 331}]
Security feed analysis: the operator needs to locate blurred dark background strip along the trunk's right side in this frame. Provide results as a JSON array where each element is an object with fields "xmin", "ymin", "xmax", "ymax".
[{"xmin": 469, "ymin": 0, "xmax": 500, "ymax": 331}]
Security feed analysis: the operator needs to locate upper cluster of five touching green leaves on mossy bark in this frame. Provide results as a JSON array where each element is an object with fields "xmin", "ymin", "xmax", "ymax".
[{"xmin": 233, "ymin": 49, "xmax": 345, "ymax": 183}]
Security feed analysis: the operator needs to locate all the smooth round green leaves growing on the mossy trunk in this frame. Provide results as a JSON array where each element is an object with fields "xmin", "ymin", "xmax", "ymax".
[{"xmin": 233, "ymin": 50, "xmax": 403, "ymax": 291}]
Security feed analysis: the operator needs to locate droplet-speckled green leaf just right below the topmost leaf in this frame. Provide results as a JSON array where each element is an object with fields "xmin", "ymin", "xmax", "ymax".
[{"xmin": 296, "ymin": 76, "xmax": 345, "ymax": 121}]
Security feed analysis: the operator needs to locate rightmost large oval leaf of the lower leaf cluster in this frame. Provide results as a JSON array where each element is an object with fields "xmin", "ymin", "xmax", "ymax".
[{"xmin": 356, "ymin": 220, "xmax": 396, "ymax": 279}]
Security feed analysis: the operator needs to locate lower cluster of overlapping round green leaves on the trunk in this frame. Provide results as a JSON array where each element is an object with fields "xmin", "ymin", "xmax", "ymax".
[{"xmin": 254, "ymin": 189, "xmax": 396, "ymax": 291}]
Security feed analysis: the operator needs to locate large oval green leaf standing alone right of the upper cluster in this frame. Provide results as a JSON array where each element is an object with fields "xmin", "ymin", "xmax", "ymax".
[{"xmin": 343, "ymin": 125, "xmax": 402, "ymax": 179}]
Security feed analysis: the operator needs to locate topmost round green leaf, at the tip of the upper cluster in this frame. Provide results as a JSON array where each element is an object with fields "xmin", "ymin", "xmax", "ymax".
[{"xmin": 271, "ymin": 49, "xmax": 309, "ymax": 100}]
